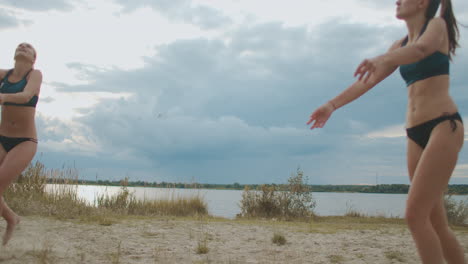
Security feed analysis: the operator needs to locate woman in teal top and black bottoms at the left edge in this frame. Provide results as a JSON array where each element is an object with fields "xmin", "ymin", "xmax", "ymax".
[{"xmin": 0, "ymin": 43, "xmax": 42, "ymax": 245}]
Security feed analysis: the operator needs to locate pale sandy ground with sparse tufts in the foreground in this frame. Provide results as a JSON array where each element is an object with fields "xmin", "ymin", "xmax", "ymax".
[{"xmin": 0, "ymin": 217, "xmax": 468, "ymax": 264}]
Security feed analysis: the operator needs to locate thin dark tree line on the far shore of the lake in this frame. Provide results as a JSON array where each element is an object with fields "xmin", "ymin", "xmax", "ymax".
[{"xmin": 47, "ymin": 179, "xmax": 468, "ymax": 195}]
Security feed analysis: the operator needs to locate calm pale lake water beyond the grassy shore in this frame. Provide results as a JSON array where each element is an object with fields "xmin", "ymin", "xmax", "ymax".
[{"xmin": 48, "ymin": 185, "xmax": 468, "ymax": 218}]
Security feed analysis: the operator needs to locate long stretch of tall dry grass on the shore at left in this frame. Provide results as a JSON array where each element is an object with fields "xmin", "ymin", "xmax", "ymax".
[{"xmin": 4, "ymin": 162, "xmax": 208, "ymax": 222}]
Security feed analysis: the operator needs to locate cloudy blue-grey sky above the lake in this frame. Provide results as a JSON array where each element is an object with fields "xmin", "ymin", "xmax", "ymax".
[{"xmin": 0, "ymin": 0, "xmax": 468, "ymax": 184}]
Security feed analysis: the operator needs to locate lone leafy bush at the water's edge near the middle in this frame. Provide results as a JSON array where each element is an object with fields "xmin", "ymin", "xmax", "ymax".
[{"xmin": 240, "ymin": 169, "xmax": 316, "ymax": 220}]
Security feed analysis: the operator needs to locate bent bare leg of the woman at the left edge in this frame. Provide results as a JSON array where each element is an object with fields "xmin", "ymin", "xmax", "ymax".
[{"xmin": 0, "ymin": 141, "xmax": 37, "ymax": 245}]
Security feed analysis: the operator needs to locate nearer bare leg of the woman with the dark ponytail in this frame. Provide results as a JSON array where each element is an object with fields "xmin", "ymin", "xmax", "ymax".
[{"xmin": 406, "ymin": 122, "xmax": 463, "ymax": 264}]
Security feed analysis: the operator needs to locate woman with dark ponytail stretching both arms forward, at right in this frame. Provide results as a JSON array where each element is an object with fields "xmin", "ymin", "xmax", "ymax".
[{"xmin": 307, "ymin": 0, "xmax": 465, "ymax": 264}]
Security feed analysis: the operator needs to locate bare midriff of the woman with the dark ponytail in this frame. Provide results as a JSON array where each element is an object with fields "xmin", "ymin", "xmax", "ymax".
[{"xmin": 406, "ymin": 75, "xmax": 458, "ymax": 128}]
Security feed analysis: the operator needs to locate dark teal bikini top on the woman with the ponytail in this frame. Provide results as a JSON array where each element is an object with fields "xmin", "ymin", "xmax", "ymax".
[{"xmin": 400, "ymin": 23, "xmax": 450, "ymax": 86}]
